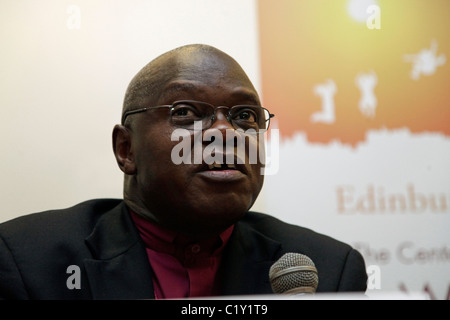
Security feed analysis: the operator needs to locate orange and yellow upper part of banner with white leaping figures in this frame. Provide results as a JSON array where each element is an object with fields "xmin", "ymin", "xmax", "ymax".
[{"xmin": 258, "ymin": 0, "xmax": 450, "ymax": 145}]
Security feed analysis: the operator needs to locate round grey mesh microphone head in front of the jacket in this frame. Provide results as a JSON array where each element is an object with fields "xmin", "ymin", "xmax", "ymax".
[{"xmin": 269, "ymin": 252, "xmax": 319, "ymax": 295}]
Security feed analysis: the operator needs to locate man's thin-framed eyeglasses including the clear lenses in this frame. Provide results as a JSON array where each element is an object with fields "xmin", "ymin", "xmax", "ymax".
[{"xmin": 122, "ymin": 100, "xmax": 275, "ymax": 133}]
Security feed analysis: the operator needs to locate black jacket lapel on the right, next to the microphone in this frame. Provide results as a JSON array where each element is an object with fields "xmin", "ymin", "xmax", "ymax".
[{"xmin": 222, "ymin": 222, "xmax": 281, "ymax": 295}]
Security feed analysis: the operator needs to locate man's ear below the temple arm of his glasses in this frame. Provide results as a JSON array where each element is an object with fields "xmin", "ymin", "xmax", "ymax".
[{"xmin": 113, "ymin": 125, "xmax": 136, "ymax": 175}]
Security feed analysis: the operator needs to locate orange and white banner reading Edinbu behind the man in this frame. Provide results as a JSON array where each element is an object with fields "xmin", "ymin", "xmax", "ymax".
[{"xmin": 258, "ymin": 0, "xmax": 450, "ymax": 299}]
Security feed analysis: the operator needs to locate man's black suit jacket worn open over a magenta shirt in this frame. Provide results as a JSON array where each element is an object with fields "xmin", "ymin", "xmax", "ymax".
[{"xmin": 0, "ymin": 199, "xmax": 367, "ymax": 299}]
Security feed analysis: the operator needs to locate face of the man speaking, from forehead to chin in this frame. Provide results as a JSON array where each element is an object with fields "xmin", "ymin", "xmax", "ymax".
[{"xmin": 121, "ymin": 51, "xmax": 263, "ymax": 234}]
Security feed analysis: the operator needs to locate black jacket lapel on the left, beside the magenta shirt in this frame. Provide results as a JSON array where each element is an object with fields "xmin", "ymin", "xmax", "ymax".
[{"xmin": 84, "ymin": 202, "xmax": 154, "ymax": 299}]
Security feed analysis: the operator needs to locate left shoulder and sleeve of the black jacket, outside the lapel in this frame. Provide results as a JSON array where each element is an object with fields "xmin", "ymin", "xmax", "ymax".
[{"xmin": 0, "ymin": 199, "xmax": 122, "ymax": 299}]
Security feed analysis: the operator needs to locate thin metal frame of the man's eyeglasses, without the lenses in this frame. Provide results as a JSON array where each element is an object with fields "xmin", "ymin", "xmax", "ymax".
[{"xmin": 122, "ymin": 100, "xmax": 275, "ymax": 133}]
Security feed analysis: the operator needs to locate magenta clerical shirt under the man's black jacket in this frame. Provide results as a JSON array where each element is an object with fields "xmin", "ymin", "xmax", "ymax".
[{"xmin": 131, "ymin": 212, "xmax": 234, "ymax": 299}]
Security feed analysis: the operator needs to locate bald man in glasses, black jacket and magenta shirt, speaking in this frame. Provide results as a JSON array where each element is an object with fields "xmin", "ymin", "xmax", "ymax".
[{"xmin": 0, "ymin": 45, "xmax": 366, "ymax": 299}]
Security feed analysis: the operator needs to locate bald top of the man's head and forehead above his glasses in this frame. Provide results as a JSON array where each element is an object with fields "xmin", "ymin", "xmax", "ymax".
[{"xmin": 123, "ymin": 45, "xmax": 260, "ymax": 112}]
